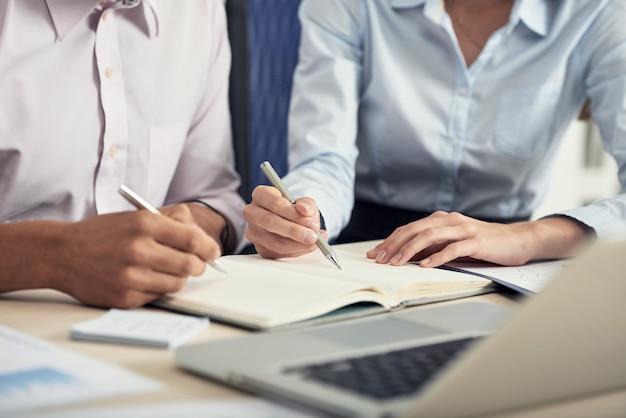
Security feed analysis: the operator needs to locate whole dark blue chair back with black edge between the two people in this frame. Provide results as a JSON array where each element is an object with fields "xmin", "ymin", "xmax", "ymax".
[{"xmin": 226, "ymin": 0, "xmax": 300, "ymax": 202}]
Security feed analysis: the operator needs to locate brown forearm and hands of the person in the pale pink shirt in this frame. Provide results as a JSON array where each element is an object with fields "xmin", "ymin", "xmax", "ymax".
[{"xmin": 0, "ymin": 204, "xmax": 226, "ymax": 308}]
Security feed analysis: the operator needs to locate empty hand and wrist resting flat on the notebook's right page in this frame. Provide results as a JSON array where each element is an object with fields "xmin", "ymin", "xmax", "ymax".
[{"xmin": 367, "ymin": 211, "xmax": 587, "ymax": 267}]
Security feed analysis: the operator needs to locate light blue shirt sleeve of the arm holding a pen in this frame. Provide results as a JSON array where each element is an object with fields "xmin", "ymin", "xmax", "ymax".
[{"xmin": 284, "ymin": 0, "xmax": 363, "ymax": 238}]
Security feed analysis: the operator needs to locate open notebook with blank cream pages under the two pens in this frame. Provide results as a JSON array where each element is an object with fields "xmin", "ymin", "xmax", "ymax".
[{"xmin": 154, "ymin": 242, "xmax": 496, "ymax": 329}]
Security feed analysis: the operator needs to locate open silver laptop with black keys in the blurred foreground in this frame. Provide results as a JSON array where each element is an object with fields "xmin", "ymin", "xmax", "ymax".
[{"xmin": 175, "ymin": 237, "xmax": 626, "ymax": 417}]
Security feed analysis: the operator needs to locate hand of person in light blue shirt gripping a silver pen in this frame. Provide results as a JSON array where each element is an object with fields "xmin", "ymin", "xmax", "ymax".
[{"xmin": 243, "ymin": 186, "xmax": 327, "ymax": 258}]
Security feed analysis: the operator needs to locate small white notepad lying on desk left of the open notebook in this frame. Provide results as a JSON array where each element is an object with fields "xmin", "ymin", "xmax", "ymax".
[{"xmin": 70, "ymin": 309, "xmax": 209, "ymax": 348}]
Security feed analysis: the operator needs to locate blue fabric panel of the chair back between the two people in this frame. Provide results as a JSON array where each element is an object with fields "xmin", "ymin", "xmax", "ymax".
[{"xmin": 248, "ymin": 0, "xmax": 300, "ymax": 190}]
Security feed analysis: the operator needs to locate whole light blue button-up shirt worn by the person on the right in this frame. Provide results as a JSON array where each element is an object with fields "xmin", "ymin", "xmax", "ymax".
[{"xmin": 285, "ymin": 0, "xmax": 626, "ymax": 237}]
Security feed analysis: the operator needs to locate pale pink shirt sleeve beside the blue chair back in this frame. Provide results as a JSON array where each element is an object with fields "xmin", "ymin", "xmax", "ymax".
[{"xmin": 166, "ymin": 1, "xmax": 246, "ymax": 252}]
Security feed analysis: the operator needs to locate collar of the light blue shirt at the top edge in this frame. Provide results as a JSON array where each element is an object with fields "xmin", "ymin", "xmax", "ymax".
[{"xmin": 389, "ymin": 0, "xmax": 554, "ymax": 36}]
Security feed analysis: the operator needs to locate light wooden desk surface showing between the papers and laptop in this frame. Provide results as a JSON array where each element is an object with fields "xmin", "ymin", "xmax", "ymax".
[{"xmin": 0, "ymin": 290, "xmax": 626, "ymax": 418}]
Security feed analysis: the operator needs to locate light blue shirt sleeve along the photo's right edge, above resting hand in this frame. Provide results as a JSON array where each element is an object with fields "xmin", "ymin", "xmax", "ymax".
[{"xmin": 558, "ymin": 1, "xmax": 626, "ymax": 237}]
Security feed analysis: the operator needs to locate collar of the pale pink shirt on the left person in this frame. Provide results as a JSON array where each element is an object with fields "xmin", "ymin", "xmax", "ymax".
[{"xmin": 46, "ymin": 0, "xmax": 159, "ymax": 40}]
